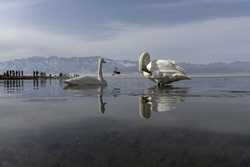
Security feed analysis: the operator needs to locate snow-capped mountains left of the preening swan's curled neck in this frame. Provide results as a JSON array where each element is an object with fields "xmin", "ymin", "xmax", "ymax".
[{"xmin": 0, "ymin": 56, "xmax": 137, "ymax": 73}]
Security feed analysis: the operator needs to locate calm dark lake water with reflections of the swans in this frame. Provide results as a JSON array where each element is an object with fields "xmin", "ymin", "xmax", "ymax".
[{"xmin": 0, "ymin": 77, "xmax": 250, "ymax": 167}]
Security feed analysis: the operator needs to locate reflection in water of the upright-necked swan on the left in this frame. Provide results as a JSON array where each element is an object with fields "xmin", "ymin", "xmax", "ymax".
[{"xmin": 64, "ymin": 85, "xmax": 107, "ymax": 114}]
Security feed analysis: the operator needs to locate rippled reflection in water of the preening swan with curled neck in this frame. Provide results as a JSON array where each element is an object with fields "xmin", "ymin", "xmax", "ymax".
[{"xmin": 139, "ymin": 86, "xmax": 188, "ymax": 119}]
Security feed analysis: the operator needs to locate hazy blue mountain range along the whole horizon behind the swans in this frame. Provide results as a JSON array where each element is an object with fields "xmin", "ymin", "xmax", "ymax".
[{"xmin": 0, "ymin": 56, "xmax": 250, "ymax": 74}]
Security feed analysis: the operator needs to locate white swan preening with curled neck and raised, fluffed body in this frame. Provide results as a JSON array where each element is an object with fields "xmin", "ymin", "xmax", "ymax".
[{"xmin": 139, "ymin": 52, "xmax": 190, "ymax": 86}]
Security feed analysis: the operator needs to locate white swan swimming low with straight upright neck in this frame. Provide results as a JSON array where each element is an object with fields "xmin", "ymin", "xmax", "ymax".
[{"xmin": 64, "ymin": 57, "xmax": 107, "ymax": 87}]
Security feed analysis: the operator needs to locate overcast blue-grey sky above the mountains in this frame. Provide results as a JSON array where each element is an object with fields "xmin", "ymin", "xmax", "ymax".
[{"xmin": 0, "ymin": 0, "xmax": 250, "ymax": 63}]
